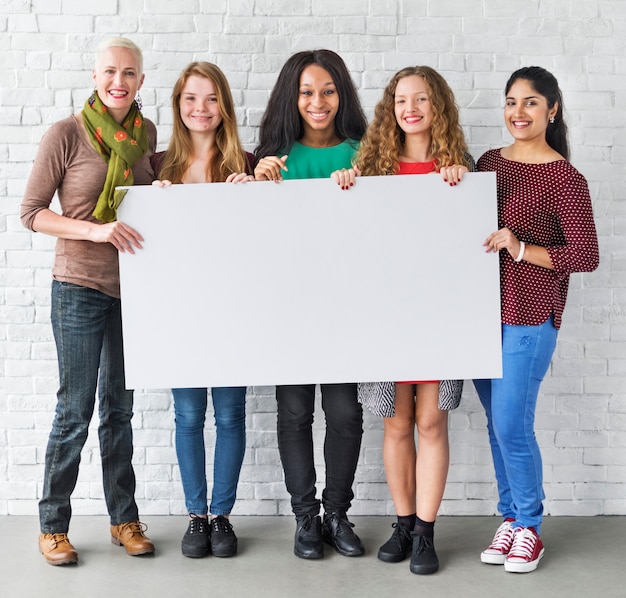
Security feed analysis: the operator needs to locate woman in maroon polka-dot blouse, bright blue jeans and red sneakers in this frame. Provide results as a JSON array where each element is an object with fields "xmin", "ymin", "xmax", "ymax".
[{"xmin": 474, "ymin": 66, "xmax": 599, "ymax": 573}]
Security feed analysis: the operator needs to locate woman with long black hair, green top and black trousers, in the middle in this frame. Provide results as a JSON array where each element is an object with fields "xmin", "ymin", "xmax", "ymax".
[{"xmin": 254, "ymin": 50, "xmax": 366, "ymax": 559}]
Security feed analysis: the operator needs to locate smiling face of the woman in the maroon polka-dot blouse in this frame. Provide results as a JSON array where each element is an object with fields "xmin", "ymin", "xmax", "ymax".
[{"xmin": 504, "ymin": 79, "xmax": 558, "ymax": 141}]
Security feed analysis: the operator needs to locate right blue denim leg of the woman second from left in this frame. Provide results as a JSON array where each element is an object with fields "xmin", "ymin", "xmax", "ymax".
[{"xmin": 210, "ymin": 386, "xmax": 246, "ymax": 515}]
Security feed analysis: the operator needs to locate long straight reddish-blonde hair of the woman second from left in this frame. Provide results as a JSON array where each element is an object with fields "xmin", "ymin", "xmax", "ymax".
[{"xmin": 157, "ymin": 62, "xmax": 249, "ymax": 183}]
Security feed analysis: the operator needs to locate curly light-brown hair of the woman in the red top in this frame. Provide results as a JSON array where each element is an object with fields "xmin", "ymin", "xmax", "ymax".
[{"xmin": 355, "ymin": 66, "xmax": 470, "ymax": 176}]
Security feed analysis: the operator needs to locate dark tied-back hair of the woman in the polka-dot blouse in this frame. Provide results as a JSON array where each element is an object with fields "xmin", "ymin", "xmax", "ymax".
[{"xmin": 504, "ymin": 66, "xmax": 569, "ymax": 160}]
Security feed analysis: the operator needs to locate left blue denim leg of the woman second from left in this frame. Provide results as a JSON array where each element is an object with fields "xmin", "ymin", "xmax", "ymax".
[{"xmin": 172, "ymin": 388, "xmax": 208, "ymax": 515}]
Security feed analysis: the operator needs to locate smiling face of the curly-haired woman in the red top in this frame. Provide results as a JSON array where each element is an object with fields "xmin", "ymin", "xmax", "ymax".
[{"xmin": 394, "ymin": 75, "xmax": 434, "ymax": 135}]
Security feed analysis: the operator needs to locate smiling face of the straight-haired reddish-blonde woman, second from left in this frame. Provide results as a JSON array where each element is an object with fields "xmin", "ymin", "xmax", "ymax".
[{"xmin": 179, "ymin": 75, "xmax": 222, "ymax": 133}]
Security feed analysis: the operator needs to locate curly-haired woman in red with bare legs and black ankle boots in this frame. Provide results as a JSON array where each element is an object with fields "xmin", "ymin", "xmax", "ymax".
[{"xmin": 333, "ymin": 66, "xmax": 474, "ymax": 575}]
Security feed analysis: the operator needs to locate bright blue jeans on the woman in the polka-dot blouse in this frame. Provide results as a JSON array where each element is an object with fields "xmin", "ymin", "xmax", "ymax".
[{"xmin": 474, "ymin": 318, "xmax": 558, "ymax": 533}]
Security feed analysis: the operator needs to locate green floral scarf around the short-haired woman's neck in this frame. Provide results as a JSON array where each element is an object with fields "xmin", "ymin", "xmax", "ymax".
[{"xmin": 82, "ymin": 91, "xmax": 148, "ymax": 222}]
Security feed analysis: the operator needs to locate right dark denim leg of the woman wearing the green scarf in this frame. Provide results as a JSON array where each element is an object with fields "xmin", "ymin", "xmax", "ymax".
[{"xmin": 98, "ymin": 300, "xmax": 139, "ymax": 525}]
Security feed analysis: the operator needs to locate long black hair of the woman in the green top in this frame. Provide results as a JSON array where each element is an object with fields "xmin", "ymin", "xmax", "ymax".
[{"xmin": 254, "ymin": 50, "xmax": 367, "ymax": 160}]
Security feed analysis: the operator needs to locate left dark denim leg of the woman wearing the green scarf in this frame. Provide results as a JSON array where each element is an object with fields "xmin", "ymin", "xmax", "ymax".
[{"xmin": 39, "ymin": 280, "xmax": 134, "ymax": 533}]
